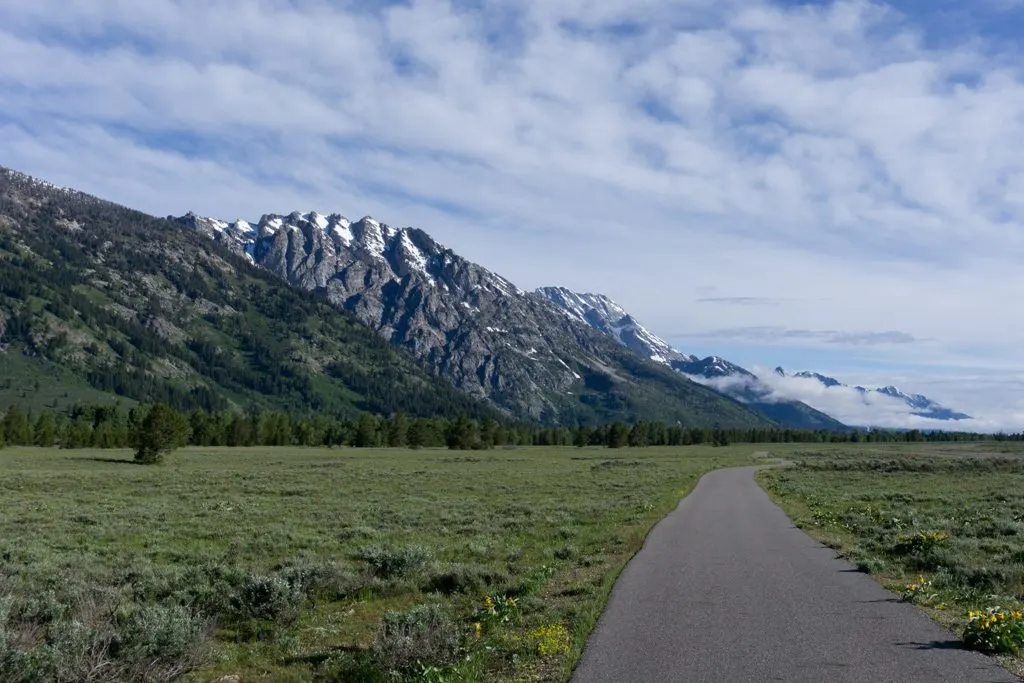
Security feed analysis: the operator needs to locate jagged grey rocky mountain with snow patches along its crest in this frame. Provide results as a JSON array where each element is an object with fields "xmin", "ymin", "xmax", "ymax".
[{"xmin": 174, "ymin": 212, "xmax": 770, "ymax": 427}]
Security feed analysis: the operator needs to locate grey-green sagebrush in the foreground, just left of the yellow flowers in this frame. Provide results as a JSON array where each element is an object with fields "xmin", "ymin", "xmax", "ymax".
[{"xmin": 373, "ymin": 605, "xmax": 460, "ymax": 673}]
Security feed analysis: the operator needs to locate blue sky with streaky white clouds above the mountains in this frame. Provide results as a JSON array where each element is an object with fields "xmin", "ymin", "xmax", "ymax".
[{"xmin": 0, "ymin": 0, "xmax": 1024, "ymax": 430}]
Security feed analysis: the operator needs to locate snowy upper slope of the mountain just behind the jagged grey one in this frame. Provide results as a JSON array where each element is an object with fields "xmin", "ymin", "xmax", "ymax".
[{"xmin": 537, "ymin": 287, "xmax": 696, "ymax": 366}]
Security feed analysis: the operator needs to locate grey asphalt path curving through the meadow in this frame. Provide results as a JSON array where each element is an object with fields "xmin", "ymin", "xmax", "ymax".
[{"xmin": 572, "ymin": 467, "xmax": 1019, "ymax": 683}]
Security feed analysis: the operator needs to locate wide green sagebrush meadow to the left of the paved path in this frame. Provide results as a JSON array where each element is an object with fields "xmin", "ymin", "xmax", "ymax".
[{"xmin": 0, "ymin": 445, "xmax": 756, "ymax": 682}]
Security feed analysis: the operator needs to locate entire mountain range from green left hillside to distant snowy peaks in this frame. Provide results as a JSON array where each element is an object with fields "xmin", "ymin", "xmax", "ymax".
[{"xmin": 0, "ymin": 165, "xmax": 966, "ymax": 429}]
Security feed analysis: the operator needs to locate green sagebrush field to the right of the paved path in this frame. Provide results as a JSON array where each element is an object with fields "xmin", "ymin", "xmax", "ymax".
[{"xmin": 760, "ymin": 442, "xmax": 1024, "ymax": 675}]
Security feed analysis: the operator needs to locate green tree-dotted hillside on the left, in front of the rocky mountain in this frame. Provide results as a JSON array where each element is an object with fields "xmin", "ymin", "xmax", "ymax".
[{"xmin": 0, "ymin": 170, "xmax": 492, "ymax": 416}]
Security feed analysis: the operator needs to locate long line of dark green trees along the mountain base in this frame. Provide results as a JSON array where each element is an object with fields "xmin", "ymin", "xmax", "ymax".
[{"xmin": 0, "ymin": 404, "xmax": 1011, "ymax": 450}]
